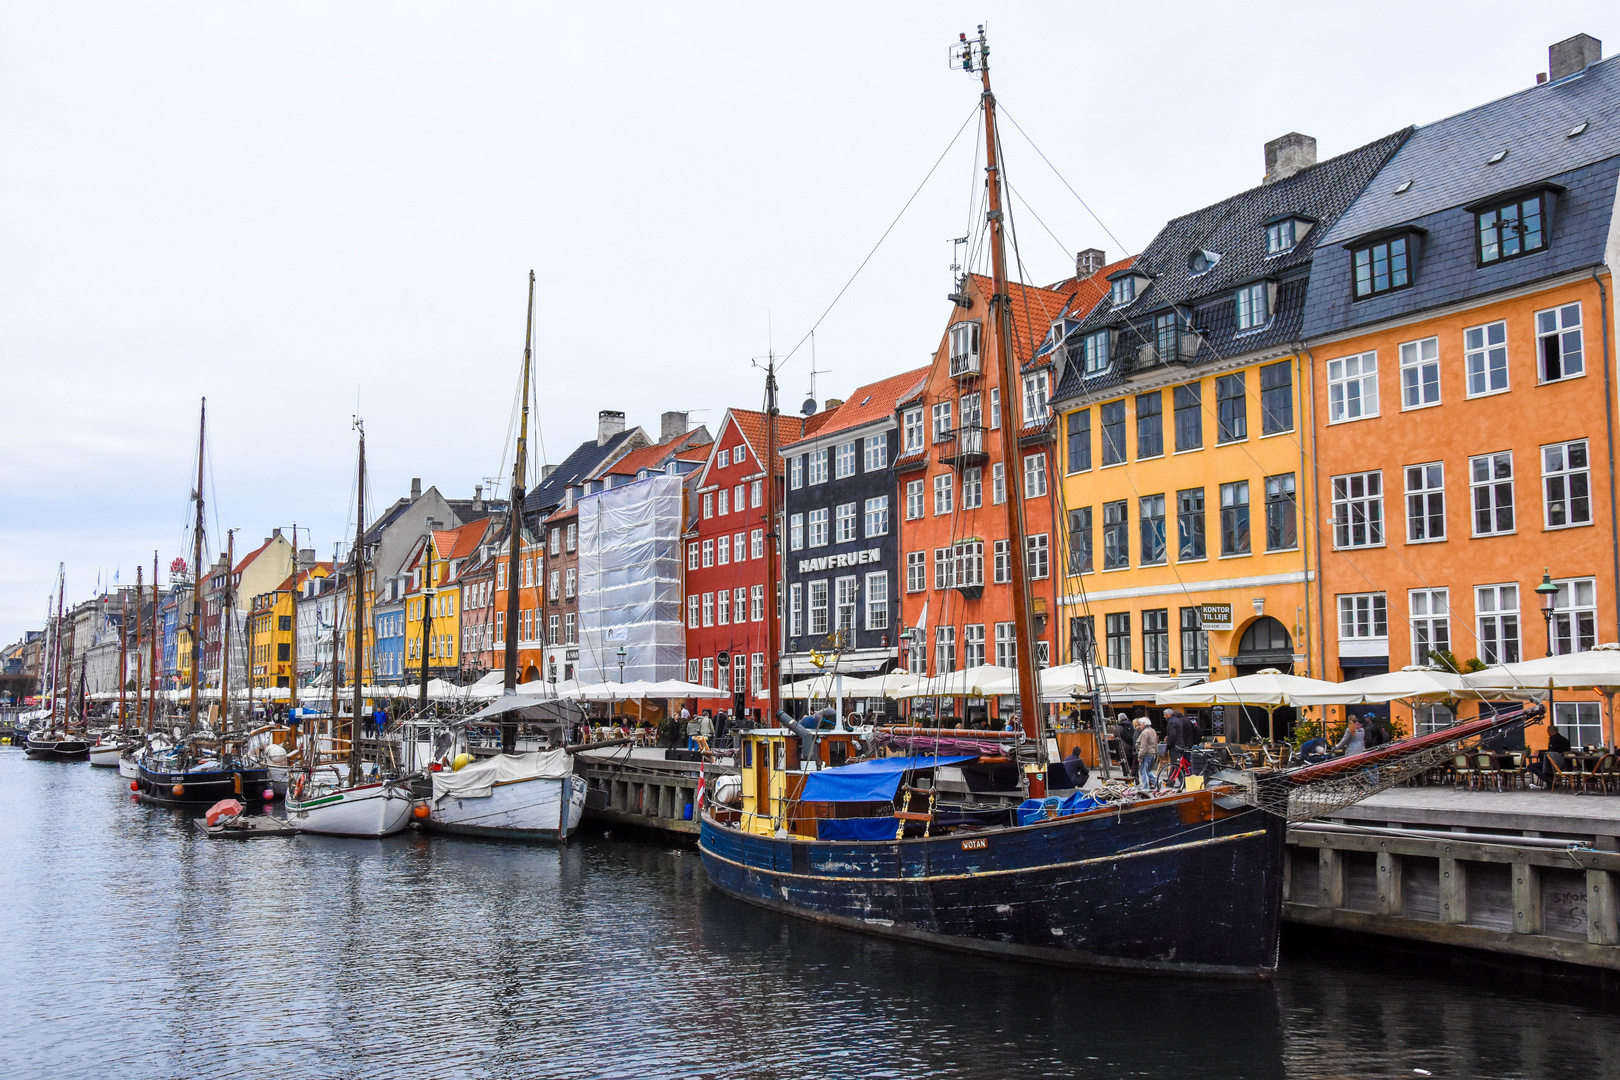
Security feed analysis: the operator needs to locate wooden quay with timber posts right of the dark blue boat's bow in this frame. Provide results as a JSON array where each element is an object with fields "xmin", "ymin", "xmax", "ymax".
[{"xmin": 1283, "ymin": 787, "xmax": 1620, "ymax": 973}]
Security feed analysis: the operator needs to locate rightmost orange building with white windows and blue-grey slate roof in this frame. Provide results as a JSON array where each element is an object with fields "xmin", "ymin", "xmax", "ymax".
[{"xmin": 1304, "ymin": 44, "xmax": 1620, "ymax": 746}]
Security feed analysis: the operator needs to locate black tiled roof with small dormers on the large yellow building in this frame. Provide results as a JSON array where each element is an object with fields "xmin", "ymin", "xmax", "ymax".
[{"xmin": 1053, "ymin": 128, "xmax": 1411, "ymax": 400}]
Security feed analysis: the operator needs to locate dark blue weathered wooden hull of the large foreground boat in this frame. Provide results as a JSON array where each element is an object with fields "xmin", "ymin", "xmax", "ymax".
[{"xmin": 698, "ymin": 793, "xmax": 1286, "ymax": 978}]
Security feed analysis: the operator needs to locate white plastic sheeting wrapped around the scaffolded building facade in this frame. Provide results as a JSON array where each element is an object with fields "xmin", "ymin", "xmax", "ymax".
[{"xmin": 578, "ymin": 476, "xmax": 687, "ymax": 683}]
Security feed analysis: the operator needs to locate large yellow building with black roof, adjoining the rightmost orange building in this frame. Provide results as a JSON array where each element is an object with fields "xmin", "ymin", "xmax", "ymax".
[{"xmin": 1050, "ymin": 131, "xmax": 1406, "ymax": 737}]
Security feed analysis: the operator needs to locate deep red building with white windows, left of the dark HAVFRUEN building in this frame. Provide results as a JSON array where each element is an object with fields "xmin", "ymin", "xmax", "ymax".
[{"xmin": 684, "ymin": 408, "xmax": 831, "ymax": 711}]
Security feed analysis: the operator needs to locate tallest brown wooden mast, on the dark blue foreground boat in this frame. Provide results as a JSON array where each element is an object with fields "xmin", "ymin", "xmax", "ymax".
[{"xmin": 956, "ymin": 26, "xmax": 1040, "ymax": 743}]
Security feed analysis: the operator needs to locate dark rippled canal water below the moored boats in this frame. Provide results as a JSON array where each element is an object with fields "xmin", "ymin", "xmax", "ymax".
[{"xmin": 0, "ymin": 748, "xmax": 1620, "ymax": 1080}]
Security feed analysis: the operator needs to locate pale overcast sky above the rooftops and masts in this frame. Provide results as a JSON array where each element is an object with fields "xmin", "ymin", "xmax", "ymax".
[{"xmin": 0, "ymin": 0, "xmax": 1620, "ymax": 643}]
